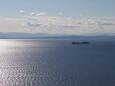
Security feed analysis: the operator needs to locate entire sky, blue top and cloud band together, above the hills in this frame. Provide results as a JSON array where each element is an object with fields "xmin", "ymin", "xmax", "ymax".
[{"xmin": 0, "ymin": 0, "xmax": 115, "ymax": 35}]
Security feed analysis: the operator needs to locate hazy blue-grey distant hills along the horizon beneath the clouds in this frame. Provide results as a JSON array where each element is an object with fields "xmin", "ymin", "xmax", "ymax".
[{"xmin": 0, "ymin": 32, "xmax": 115, "ymax": 39}]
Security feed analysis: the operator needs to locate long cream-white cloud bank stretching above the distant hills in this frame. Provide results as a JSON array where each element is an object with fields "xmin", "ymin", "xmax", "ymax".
[{"xmin": 0, "ymin": 15, "xmax": 115, "ymax": 35}]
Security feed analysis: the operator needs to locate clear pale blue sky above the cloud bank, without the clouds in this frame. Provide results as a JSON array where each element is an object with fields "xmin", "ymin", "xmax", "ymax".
[{"xmin": 0, "ymin": 0, "xmax": 115, "ymax": 17}]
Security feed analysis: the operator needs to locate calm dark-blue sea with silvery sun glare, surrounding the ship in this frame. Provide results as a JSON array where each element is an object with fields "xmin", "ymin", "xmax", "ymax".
[{"xmin": 0, "ymin": 38, "xmax": 115, "ymax": 86}]
